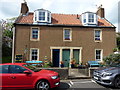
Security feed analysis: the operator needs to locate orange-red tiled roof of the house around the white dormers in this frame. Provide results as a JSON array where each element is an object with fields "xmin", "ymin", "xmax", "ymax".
[{"xmin": 17, "ymin": 13, "xmax": 112, "ymax": 26}]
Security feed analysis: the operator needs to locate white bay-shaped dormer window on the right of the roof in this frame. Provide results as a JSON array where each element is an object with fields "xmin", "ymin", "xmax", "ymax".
[{"xmin": 81, "ymin": 12, "xmax": 98, "ymax": 26}]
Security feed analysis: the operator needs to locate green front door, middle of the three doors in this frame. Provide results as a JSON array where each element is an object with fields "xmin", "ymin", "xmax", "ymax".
[{"xmin": 62, "ymin": 49, "xmax": 70, "ymax": 67}]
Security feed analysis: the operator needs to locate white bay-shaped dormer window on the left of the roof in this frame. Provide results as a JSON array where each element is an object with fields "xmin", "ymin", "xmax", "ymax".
[{"xmin": 34, "ymin": 9, "xmax": 51, "ymax": 24}]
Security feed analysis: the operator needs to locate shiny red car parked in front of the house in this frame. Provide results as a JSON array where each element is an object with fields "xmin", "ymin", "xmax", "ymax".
[{"xmin": 0, "ymin": 63, "xmax": 60, "ymax": 90}]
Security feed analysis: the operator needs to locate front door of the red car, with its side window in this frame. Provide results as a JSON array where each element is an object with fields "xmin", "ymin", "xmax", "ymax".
[{"xmin": 10, "ymin": 65, "xmax": 34, "ymax": 88}]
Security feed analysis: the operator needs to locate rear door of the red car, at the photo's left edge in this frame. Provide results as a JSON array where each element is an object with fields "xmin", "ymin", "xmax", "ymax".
[{"xmin": 0, "ymin": 65, "xmax": 11, "ymax": 87}]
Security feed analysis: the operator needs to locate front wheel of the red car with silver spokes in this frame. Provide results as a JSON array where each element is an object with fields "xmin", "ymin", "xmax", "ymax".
[{"xmin": 36, "ymin": 80, "xmax": 50, "ymax": 90}]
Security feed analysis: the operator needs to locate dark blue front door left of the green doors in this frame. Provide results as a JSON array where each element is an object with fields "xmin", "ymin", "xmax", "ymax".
[{"xmin": 52, "ymin": 49, "xmax": 60, "ymax": 67}]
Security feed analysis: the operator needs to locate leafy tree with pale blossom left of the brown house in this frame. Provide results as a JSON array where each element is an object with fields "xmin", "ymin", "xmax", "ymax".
[{"xmin": 1, "ymin": 18, "xmax": 16, "ymax": 62}]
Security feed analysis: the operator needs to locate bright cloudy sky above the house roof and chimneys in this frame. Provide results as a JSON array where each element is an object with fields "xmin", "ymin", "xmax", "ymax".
[{"xmin": 0, "ymin": 0, "xmax": 120, "ymax": 32}]
